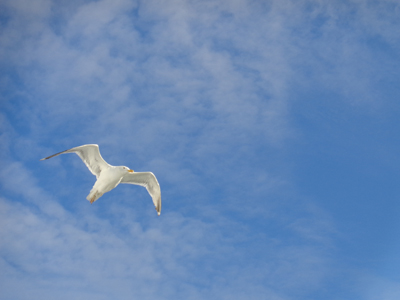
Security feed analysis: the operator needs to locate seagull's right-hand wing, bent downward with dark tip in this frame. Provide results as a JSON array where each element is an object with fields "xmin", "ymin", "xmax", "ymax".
[{"xmin": 121, "ymin": 172, "xmax": 161, "ymax": 215}]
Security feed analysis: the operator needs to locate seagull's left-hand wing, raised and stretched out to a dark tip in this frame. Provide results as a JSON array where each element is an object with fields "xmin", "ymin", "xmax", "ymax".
[{"xmin": 41, "ymin": 144, "xmax": 110, "ymax": 177}]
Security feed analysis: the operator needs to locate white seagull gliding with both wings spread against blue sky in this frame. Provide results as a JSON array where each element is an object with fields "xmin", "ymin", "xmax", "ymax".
[{"xmin": 41, "ymin": 144, "xmax": 161, "ymax": 215}]
